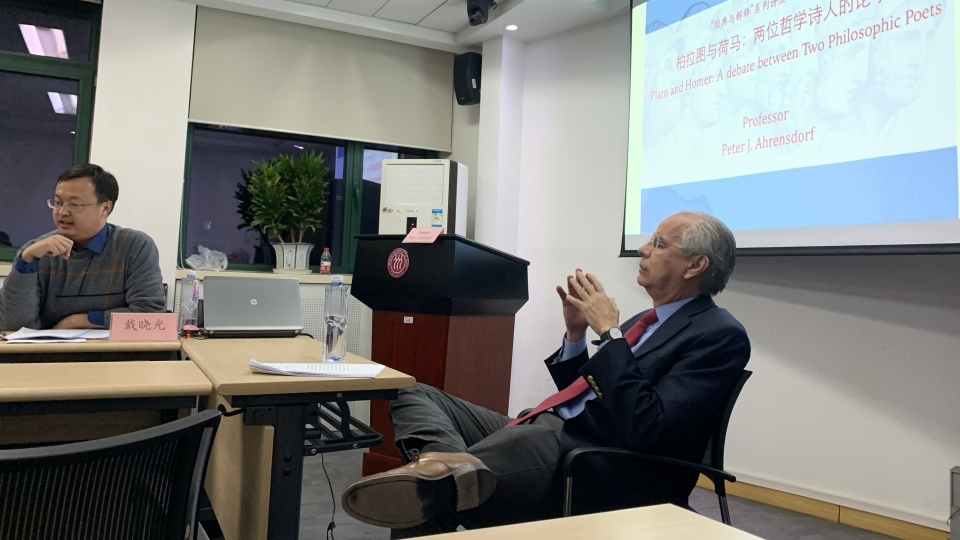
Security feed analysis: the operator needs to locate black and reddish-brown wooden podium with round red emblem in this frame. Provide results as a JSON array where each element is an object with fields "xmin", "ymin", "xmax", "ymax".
[{"xmin": 351, "ymin": 235, "xmax": 530, "ymax": 476}]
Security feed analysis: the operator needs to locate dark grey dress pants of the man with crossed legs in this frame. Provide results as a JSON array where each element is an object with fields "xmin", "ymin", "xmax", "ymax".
[{"xmin": 390, "ymin": 383, "xmax": 563, "ymax": 529}]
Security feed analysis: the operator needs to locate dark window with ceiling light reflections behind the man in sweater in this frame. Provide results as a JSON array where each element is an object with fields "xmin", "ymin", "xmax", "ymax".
[{"xmin": 0, "ymin": 0, "xmax": 100, "ymax": 261}]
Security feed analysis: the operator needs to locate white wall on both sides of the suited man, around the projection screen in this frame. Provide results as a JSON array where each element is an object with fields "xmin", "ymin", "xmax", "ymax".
[{"xmin": 506, "ymin": 11, "xmax": 960, "ymax": 529}]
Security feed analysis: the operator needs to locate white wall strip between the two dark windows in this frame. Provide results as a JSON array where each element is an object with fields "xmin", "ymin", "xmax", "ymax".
[{"xmin": 90, "ymin": 0, "xmax": 196, "ymax": 284}]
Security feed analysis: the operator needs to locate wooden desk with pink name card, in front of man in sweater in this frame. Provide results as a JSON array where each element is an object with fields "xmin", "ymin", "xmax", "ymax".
[{"xmin": 0, "ymin": 339, "xmax": 180, "ymax": 364}]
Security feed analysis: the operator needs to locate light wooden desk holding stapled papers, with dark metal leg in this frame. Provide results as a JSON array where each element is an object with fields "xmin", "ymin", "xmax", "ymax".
[{"xmin": 181, "ymin": 337, "xmax": 416, "ymax": 540}]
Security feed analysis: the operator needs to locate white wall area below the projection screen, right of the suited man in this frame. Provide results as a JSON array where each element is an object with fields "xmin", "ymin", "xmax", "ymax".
[{"xmin": 720, "ymin": 256, "xmax": 960, "ymax": 529}]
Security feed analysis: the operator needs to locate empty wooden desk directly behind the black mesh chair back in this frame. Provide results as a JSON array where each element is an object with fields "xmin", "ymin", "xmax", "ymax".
[{"xmin": 0, "ymin": 361, "xmax": 213, "ymax": 446}]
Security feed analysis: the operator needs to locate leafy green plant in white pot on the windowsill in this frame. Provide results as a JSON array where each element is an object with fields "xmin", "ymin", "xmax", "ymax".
[{"xmin": 235, "ymin": 151, "xmax": 330, "ymax": 273}]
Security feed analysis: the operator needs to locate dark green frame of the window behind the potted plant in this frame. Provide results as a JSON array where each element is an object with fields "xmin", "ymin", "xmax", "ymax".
[{"xmin": 177, "ymin": 122, "xmax": 439, "ymax": 274}]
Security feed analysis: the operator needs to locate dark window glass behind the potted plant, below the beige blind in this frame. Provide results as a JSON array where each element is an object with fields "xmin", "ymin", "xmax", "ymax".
[{"xmin": 180, "ymin": 124, "xmax": 436, "ymax": 273}]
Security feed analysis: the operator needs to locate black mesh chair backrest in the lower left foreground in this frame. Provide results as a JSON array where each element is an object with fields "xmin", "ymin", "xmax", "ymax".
[{"xmin": 0, "ymin": 410, "xmax": 220, "ymax": 540}]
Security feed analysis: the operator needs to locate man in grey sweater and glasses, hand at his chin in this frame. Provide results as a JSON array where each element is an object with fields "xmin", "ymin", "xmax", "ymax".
[{"xmin": 0, "ymin": 164, "xmax": 165, "ymax": 330}]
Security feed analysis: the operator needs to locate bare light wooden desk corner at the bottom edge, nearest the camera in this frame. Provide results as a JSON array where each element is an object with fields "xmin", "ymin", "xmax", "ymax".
[{"xmin": 416, "ymin": 504, "xmax": 758, "ymax": 540}]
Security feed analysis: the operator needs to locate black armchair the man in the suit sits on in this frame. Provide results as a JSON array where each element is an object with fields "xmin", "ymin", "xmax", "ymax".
[{"xmin": 563, "ymin": 369, "xmax": 753, "ymax": 525}]
